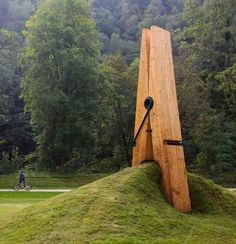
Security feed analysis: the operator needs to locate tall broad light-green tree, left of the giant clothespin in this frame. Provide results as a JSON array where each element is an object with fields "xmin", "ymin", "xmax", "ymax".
[{"xmin": 22, "ymin": 0, "xmax": 100, "ymax": 170}]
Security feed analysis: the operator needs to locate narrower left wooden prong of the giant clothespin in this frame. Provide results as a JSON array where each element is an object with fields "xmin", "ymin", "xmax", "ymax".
[{"xmin": 132, "ymin": 29, "xmax": 152, "ymax": 166}]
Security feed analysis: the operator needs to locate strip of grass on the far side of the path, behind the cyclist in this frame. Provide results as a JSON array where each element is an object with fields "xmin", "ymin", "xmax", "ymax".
[{"xmin": 0, "ymin": 173, "xmax": 107, "ymax": 189}]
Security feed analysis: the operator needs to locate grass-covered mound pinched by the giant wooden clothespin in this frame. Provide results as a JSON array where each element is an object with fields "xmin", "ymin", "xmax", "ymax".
[{"xmin": 0, "ymin": 163, "xmax": 236, "ymax": 243}]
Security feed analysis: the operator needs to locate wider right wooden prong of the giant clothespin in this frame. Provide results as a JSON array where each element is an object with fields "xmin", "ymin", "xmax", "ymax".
[{"xmin": 149, "ymin": 27, "xmax": 191, "ymax": 212}]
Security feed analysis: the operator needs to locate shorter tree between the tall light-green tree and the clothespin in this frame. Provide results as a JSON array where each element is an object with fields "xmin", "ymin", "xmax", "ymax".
[{"xmin": 98, "ymin": 55, "xmax": 138, "ymax": 169}]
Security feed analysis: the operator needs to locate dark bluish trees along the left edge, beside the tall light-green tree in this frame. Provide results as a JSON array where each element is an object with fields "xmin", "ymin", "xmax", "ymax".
[{"xmin": 0, "ymin": 0, "xmax": 35, "ymax": 173}]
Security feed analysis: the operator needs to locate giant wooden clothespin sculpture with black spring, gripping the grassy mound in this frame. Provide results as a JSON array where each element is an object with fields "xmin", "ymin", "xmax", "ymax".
[{"xmin": 132, "ymin": 26, "xmax": 191, "ymax": 212}]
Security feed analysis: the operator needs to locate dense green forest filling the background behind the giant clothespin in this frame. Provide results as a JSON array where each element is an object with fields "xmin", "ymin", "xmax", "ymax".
[{"xmin": 0, "ymin": 0, "xmax": 236, "ymax": 184}]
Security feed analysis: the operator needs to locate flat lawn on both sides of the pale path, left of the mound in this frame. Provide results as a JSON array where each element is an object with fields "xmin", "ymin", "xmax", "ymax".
[{"xmin": 0, "ymin": 172, "xmax": 106, "ymax": 224}]
